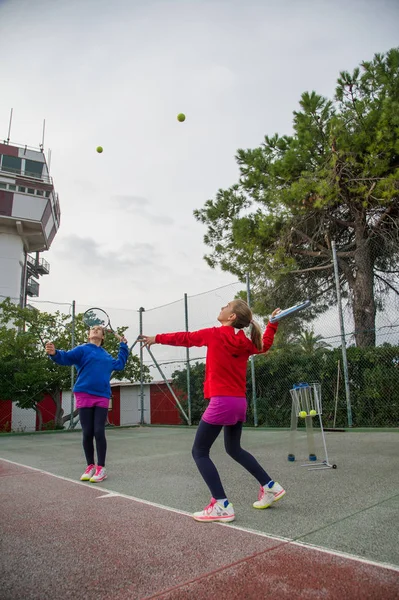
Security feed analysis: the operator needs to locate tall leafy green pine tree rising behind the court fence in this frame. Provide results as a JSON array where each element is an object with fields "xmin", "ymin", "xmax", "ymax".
[{"xmin": 194, "ymin": 48, "xmax": 399, "ymax": 347}]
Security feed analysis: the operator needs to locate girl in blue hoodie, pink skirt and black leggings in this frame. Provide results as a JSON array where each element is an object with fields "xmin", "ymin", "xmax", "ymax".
[{"xmin": 46, "ymin": 326, "xmax": 129, "ymax": 483}]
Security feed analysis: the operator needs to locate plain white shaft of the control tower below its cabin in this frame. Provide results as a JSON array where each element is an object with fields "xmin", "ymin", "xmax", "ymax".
[{"xmin": 0, "ymin": 233, "xmax": 24, "ymax": 301}]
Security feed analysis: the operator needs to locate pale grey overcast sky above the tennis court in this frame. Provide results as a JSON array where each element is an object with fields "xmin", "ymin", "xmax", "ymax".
[{"xmin": 0, "ymin": 0, "xmax": 399, "ymax": 316}]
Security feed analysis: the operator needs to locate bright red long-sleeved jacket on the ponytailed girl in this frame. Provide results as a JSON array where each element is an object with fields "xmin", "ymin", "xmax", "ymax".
[{"xmin": 155, "ymin": 323, "xmax": 278, "ymax": 398}]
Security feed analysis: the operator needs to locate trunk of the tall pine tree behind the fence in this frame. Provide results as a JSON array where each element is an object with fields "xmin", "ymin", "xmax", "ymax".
[{"xmin": 352, "ymin": 214, "xmax": 376, "ymax": 348}]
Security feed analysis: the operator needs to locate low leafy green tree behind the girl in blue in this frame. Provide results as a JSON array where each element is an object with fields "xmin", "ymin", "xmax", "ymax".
[{"xmin": 0, "ymin": 300, "xmax": 150, "ymax": 428}]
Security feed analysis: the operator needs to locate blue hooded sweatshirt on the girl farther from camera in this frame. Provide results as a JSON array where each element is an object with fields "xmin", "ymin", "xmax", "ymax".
[{"xmin": 50, "ymin": 342, "xmax": 129, "ymax": 398}]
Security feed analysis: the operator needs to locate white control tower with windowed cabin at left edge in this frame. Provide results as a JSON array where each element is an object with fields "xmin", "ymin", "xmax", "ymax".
[{"xmin": 0, "ymin": 142, "xmax": 61, "ymax": 306}]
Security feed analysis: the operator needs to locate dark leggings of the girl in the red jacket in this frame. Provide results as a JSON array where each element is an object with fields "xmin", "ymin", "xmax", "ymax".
[{"xmin": 192, "ymin": 419, "xmax": 271, "ymax": 500}]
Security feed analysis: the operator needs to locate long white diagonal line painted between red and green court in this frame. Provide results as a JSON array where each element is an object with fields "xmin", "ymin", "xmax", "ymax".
[{"xmin": 0, "ymin": 457, "xmax": 399, "ymax": 573}]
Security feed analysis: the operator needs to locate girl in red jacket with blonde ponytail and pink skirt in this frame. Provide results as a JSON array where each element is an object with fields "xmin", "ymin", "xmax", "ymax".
[{"xmin": 140, "ymin": 300, "xmax": 285, "ymax": 522}]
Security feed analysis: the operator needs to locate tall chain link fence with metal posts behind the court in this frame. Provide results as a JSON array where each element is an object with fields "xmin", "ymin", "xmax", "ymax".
[{"xmin": 0, "ymin": 282, "xmax": 399, "ymax": 432}]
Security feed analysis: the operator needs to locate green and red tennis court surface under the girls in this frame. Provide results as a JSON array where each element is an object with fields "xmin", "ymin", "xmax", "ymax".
[{"xmin": 0, "ymin": 428, "xmax": 399, "ymax": 600}]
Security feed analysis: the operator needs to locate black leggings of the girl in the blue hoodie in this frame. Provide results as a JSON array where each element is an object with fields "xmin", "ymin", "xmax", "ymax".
[{"xmin": 79, "ymin": 406, "xmax": 108, "ymax": 467}]
